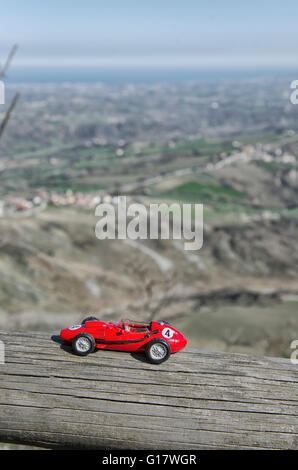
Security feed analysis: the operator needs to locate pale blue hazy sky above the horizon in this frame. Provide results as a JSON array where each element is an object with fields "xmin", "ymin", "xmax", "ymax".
[{"xmin": 0, "ymin": 0, "xmax": 298, "ymax": 67}]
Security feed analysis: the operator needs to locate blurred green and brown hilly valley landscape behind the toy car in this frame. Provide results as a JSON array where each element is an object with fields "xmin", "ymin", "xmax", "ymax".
[{"xmin": 0, "ymin": 79, "xmax": 298, "ymax": 356}]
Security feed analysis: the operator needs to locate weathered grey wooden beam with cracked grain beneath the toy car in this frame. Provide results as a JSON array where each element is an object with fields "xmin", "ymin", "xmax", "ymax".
[{"xmin": 0, "ymin": 331, "xmax": 298, "ymax": 449}]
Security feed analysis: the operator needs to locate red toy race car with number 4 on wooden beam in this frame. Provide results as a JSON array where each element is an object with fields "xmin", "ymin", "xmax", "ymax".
[{"xmin": 60, "ymin": 317, "xmax": 187, "ymax": 364}]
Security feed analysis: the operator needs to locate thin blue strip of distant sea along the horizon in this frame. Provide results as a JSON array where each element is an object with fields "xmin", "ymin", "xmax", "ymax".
[{"xmin": 6, "ymin": 66, "xmax": 298, "ymax": 84}]
